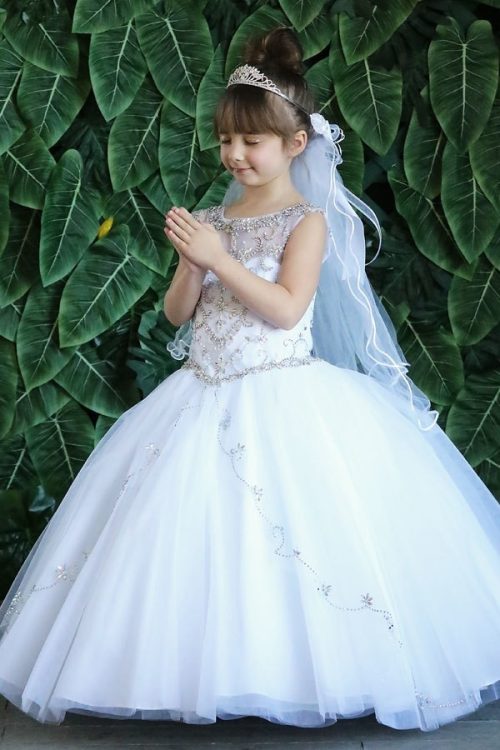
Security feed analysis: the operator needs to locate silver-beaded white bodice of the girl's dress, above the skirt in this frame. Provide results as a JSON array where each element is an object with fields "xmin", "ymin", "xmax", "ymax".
[{"xmin": 183, "ymin": 202, "xmax": 321, "ymax": 383}]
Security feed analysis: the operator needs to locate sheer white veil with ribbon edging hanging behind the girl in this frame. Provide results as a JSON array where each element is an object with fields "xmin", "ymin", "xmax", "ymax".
[{"xmin": 167, "ymin": 112, "xmax": 439, "ymax": 430}]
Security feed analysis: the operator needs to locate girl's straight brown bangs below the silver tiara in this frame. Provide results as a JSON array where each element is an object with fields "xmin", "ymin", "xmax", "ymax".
[{"xmin": 214, "ymin": 85, "xmax": 294, "ymax": 138}]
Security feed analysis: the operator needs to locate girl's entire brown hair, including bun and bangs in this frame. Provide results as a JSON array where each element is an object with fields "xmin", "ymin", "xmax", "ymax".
[{"xmin": 214, "ymin": 26, "xmax": 315, "ymax": 147}]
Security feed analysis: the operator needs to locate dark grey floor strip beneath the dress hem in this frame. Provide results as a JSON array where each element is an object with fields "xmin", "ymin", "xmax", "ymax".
[{"xmin": 0, "ymin": 697, "xmax": 500, "ymax": 750}]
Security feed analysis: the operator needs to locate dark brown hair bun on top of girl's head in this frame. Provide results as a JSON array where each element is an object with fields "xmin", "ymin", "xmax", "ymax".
[{"xmin": 244, "ymin": 26, "xmax": 303, "ymax": 75}]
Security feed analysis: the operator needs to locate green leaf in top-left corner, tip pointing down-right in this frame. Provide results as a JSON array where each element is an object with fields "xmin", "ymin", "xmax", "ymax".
[{"xmin": 3, "ymin": 9, "xmax": 78, "ymax": 78}]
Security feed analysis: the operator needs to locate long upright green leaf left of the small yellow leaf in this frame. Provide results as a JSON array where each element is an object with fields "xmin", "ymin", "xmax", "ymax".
[{"xmin": 40, "ymin": 149, "xmax": 101, "ymax": 286}]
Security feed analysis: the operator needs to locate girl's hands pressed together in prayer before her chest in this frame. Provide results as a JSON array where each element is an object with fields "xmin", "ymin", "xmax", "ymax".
[{"xmin": 165, "ymin": 208, "xmax": 226, "ymax": 270}]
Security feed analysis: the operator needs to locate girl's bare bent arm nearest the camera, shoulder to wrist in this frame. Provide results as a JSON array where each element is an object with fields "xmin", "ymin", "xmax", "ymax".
[{"xmin": 211, "ymin": 212, "xmax": 327, "ymax": 330}]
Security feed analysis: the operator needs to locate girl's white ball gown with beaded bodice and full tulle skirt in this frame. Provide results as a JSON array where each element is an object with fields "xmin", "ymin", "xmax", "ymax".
[{"xmin": 0, "ymin": 202, "xmax": 500, "ymax": 731}]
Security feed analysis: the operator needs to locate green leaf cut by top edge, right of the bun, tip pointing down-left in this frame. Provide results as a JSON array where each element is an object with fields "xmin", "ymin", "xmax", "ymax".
[{"xmin": 339, "ymin": 0, "xmax": 418, "ymax": 65}]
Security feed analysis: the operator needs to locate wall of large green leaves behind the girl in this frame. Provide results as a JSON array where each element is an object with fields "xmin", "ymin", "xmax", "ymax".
[{"xmin": 0, "ymin": 0, "xmax": 500, "ymax": 591}]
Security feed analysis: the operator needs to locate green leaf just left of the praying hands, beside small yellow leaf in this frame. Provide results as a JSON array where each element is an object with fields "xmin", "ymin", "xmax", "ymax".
[{"xmin": 106, "ymin": 190, "xmax": 173, "ymax": 275}]
